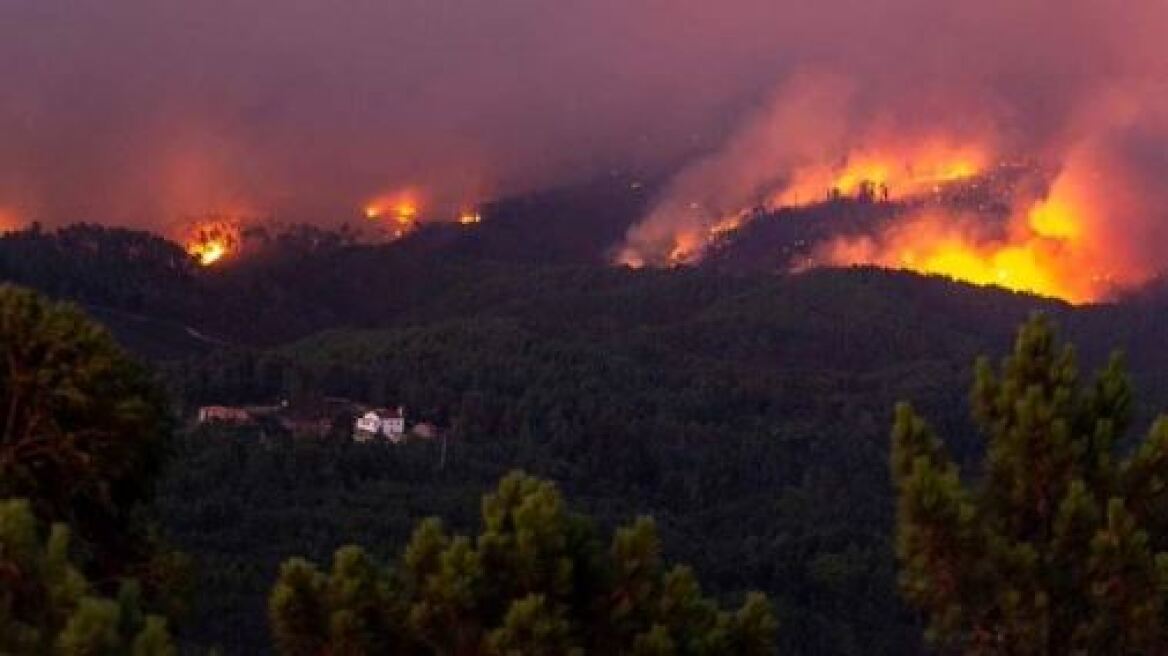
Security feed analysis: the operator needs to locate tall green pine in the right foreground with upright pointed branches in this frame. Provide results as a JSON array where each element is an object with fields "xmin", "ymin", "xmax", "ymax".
[{"xmin": 892, "ymin": 316, "xmax": 1168, "ymax": 654}]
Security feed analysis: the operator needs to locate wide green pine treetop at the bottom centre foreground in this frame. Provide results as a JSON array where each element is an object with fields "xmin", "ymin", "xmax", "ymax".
[{"xmin": 269, "ymin": 473, "xmax": 776, "ymax": 656}]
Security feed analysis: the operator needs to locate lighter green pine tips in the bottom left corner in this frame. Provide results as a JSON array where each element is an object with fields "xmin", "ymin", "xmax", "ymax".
[{"xmin": 0, "ymin": 500, "xmax": 175, "ymax": 656}]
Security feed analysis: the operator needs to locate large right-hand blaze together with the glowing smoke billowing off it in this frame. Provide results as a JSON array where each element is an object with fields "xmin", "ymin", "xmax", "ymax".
[{"xmin": 617, "ymin": 74, "xmax": 1168, "ymax": 302}]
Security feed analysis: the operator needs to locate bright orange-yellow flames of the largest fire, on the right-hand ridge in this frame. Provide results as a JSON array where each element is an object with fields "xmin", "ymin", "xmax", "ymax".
[{"xmin": 619, "ymin": 148, "xmax": 1125, "ymax": 303}]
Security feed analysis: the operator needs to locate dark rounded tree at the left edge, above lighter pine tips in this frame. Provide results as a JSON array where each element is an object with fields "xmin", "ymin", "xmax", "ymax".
[{"xmin": 0, "ymin": 285, "xmax": 169, "ymax": 579}]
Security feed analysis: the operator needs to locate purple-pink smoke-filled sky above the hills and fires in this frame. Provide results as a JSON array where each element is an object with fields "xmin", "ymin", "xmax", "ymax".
[{"xmin": 0, "ymin": 0, "xmax": 1168, "ymax": 225}]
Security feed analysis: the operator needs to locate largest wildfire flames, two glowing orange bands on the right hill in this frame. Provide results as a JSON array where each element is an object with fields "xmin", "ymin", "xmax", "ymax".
[{"xmin": 617, "ymin": 135, "xmax": 1149, "ymax": 302}]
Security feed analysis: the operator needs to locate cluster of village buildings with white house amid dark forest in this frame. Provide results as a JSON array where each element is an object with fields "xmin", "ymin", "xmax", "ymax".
[{"xmin": 195, "ymin": 399, "xmax": 438, "ymax": 444}]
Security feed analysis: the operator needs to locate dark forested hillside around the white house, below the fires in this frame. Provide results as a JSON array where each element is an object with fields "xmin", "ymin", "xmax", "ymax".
[{"xmin": 0, "ymin": 222, "xmax": 1168, "ymax": 654}]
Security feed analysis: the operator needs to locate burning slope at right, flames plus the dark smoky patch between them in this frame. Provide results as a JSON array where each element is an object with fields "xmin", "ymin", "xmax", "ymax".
[{"xmin": 630, "ymin": 150, "xmax": 1121, "ymax": 302}]
